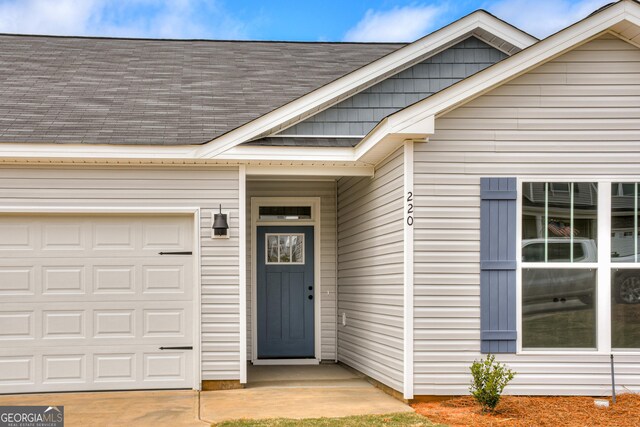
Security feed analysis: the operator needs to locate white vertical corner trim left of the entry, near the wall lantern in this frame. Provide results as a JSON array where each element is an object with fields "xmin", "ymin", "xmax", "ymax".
[{"xmin": 238, "ymin": 165, "xmax": 247, "ymax": 384}]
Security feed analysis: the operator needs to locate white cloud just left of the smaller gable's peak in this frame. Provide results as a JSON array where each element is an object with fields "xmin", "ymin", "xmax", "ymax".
[{"xmin": 344, "ymin": 6, "xmax": 443, "ymax": 42}]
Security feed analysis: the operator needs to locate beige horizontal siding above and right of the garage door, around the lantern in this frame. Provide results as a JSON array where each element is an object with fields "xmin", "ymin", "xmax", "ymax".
[{"xmin": 0, "ymin": 166, "xmax": 240, "ymax": 380}]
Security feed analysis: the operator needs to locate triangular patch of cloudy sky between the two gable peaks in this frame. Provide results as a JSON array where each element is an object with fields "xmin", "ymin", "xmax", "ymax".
[{"xmin": 487, "ymin": 0, "xmax": 612, "ymax": 38}]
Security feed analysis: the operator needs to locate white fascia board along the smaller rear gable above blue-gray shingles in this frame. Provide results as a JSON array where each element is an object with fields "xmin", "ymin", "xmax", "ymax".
[{"xmin": 197, "ymin": 11, "xmax": 536, "ymax": 158}]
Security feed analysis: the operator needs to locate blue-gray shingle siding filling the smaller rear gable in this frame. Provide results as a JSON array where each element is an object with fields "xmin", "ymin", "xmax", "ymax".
[{"xmin": 279, "ymin": 36, "xmax": 507, "ymax": 136}]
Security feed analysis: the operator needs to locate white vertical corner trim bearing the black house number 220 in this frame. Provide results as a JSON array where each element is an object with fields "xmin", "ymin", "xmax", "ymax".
[{"xmin": 402, "ymin": 141, "xmax": 415, "ymax": 399}]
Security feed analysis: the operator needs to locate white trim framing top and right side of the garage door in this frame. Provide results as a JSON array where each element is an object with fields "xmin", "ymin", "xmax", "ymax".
[{"xmin": 0, "ymin": 206, "xmax": 202, "ymax": 390}]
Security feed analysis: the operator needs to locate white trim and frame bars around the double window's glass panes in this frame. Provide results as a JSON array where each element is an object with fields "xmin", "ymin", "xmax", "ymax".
[{"xmin": 516, "ymin": 175, "xmax": 640, "ymax": 356}]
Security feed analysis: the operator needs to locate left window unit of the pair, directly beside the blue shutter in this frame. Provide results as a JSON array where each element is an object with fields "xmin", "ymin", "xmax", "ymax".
[{"xmin": 522, "ymin": 182, "xmax": 598, "ymax": 349}]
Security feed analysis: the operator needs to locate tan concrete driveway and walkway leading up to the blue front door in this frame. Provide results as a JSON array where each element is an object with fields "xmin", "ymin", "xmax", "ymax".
[{"xmin": 0, "ymin": 365, "xmax": 412, "ymax": 427}]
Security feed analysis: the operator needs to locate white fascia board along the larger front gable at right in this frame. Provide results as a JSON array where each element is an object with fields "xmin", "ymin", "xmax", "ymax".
[{"xmin": 382, "ymin": 1, "xmax": 640, "ymax": 134}]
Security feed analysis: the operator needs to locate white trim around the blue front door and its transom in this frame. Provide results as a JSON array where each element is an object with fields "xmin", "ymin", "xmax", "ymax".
[{"xmin": 251, "ymin": 197, "xmax": 322, "ymax": 365}]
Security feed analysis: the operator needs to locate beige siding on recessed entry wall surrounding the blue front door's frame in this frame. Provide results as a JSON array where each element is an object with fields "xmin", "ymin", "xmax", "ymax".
[{"xmin": 246, "ymin": 180, "xmax": 336, "ymax": 361}]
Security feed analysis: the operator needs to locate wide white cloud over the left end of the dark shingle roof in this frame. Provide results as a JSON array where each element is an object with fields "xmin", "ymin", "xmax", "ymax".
[{"xmin": 0, "ymin": 0, "xmax": 248, "ymax": 39}]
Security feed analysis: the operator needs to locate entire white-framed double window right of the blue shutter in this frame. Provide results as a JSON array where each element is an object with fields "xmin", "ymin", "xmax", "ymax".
[{"xmin": 520, "ymin": 180, "xmax": 640, "ymax": 351}]
